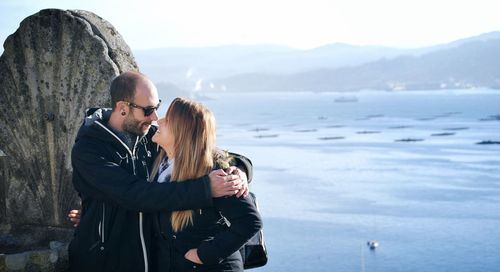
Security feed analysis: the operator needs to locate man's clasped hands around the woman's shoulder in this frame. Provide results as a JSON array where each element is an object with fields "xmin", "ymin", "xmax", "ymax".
[{"xmin": 208, "ymin": 166, "xmax": 248, "ymax": 197}]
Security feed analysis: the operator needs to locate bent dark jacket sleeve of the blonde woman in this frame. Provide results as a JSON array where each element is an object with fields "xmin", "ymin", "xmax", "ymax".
[{"xmin": 194, "ymin": 196, "xmax": 262, "ymax": 264}]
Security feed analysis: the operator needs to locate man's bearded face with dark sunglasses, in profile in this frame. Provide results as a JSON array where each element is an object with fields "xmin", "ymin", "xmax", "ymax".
[{"xmin": 123, "ymin": 80, "xmax": 160, "ymax": 136}]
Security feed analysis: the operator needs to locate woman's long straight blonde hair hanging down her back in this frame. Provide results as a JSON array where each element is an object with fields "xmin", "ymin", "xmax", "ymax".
[{"xmin": 152, "ymin": 97, "xmax": 216, "ymax": 232}]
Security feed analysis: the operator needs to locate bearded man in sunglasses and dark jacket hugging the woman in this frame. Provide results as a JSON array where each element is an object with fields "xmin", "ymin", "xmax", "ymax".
[{"xmin": 69, "ymin": 72, "xmax": 251, "ymax": 271}]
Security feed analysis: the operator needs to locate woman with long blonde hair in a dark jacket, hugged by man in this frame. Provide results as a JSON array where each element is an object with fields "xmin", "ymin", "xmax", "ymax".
[{"xmin": 152, "ymin": 98, "xmax": 262, "ymax": 271}]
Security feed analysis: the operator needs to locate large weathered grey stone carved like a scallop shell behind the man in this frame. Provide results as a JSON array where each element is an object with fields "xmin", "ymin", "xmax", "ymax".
[{"xmin": 0, "ymin": 9, "xmax": 138, "ymax": 271}]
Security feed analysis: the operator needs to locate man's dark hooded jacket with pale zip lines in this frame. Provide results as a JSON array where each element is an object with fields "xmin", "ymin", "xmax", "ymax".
[{"xmin": 69, "ymin": 110, "xmax": 213, "ymax": 271}]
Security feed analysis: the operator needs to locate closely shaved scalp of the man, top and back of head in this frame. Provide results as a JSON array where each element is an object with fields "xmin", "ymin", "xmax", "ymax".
[{"xmin": 109, "ymin": 71, "xmax": 154, "ymax": 110}]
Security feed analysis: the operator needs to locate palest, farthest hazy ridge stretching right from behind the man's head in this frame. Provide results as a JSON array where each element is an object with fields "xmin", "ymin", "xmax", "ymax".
[{"xmin": 134, "ymin": 44, "xmax": 410, "ymax": 85}]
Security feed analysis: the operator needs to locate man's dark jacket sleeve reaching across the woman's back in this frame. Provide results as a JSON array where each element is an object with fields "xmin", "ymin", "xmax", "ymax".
[{"xmin": 71, "ymin": 142, "xmax": 213, "ymax": 212}]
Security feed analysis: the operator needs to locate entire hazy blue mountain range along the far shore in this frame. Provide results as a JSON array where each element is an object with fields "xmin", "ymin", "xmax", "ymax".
[{"xmin": 134, "ymin": 32, "xmax": 500, "ymax": 95}]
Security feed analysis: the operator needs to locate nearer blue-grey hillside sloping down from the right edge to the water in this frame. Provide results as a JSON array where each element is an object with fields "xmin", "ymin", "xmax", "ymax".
[{"xmin": 214, "ymin": 39, "xmax": 500, "ymax": 91}]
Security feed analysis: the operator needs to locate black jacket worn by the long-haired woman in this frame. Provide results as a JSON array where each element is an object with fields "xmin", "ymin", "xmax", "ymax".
[{"xmin": 153, "ymin": 159, "xmax": 262, "ymax": 272}]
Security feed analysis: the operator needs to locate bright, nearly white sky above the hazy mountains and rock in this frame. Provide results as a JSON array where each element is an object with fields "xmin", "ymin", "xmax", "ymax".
[{"xmin": 0, "ymin": 0, "xmax": 500, "ymax": 51}]
